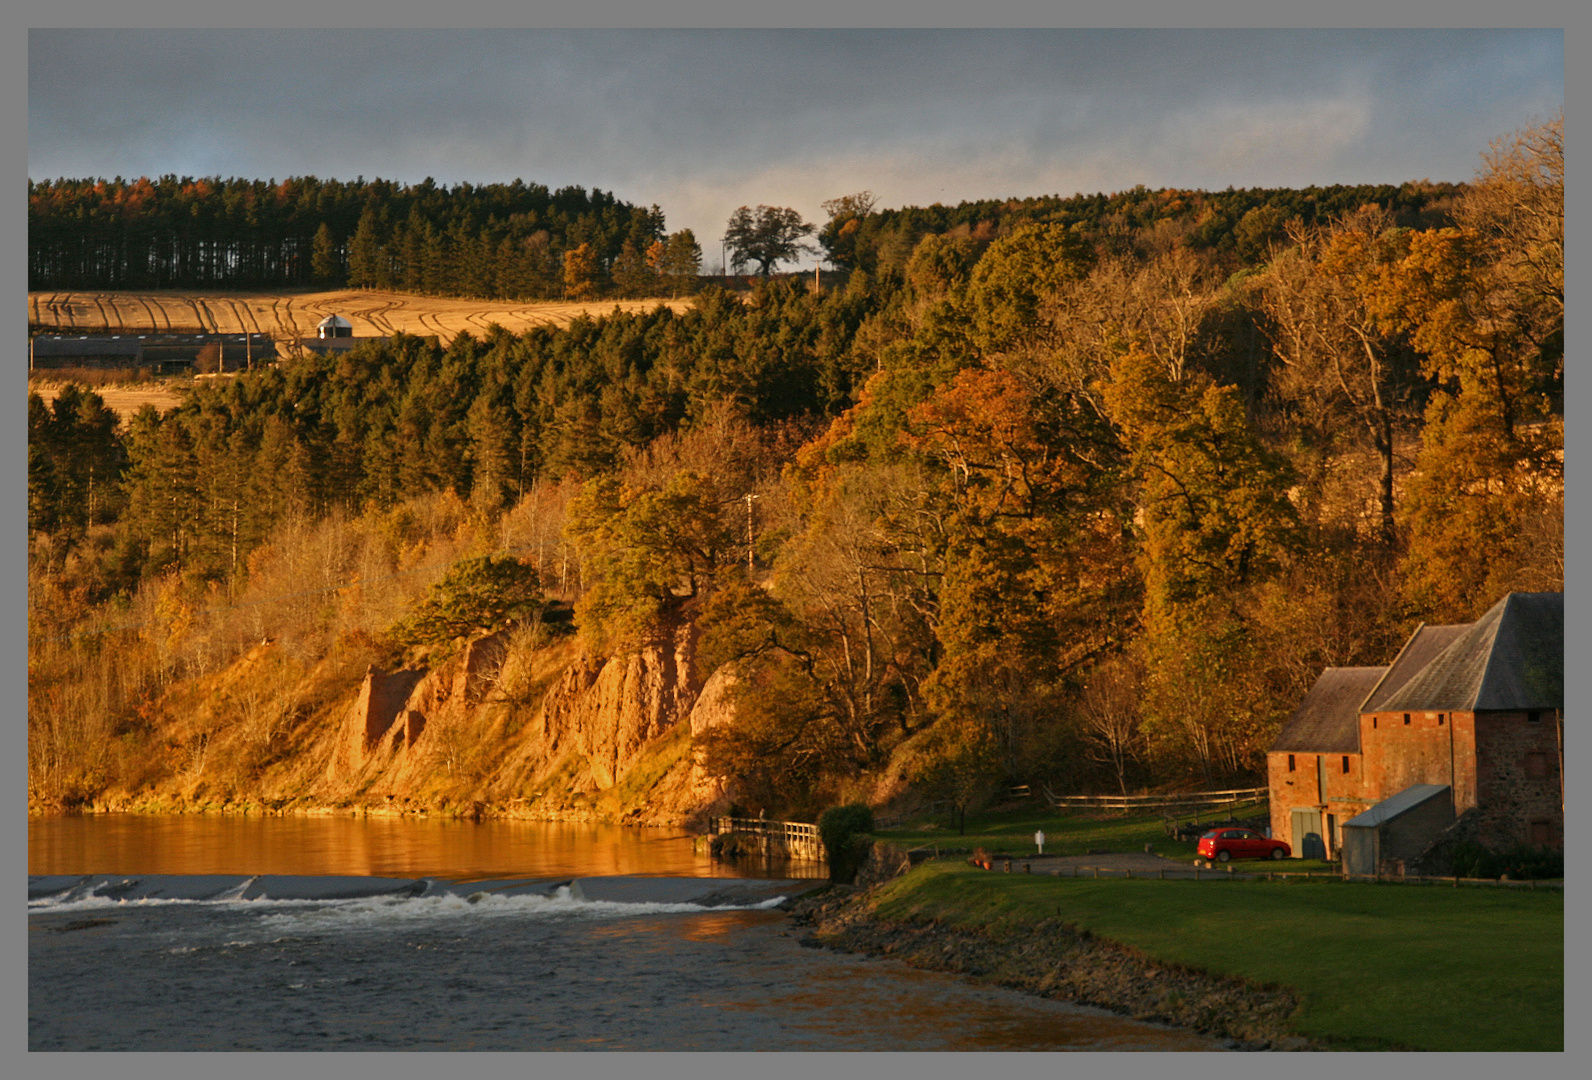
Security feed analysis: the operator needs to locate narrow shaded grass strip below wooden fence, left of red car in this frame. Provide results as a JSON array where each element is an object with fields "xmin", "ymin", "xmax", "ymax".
[{"xmin": 872, "ymin": 803, "xmax": 1336, "ymax": 873}]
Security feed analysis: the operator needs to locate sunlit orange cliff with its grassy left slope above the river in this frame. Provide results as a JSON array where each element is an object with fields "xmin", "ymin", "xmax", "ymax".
[{"xmin": 122, "ymin": 621, "xmax": 734, "ymax": 825}]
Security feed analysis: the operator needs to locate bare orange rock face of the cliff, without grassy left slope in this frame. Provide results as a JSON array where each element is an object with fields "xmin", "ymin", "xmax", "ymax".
[{"xmin": 315, "ymin": 621, "xmax": 734, "ymax": 822}]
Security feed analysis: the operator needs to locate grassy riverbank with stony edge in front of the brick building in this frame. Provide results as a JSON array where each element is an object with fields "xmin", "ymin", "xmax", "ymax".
[{"xmin": 791, "ymin": 862, "xmax": 1563, "ymax": 1051}]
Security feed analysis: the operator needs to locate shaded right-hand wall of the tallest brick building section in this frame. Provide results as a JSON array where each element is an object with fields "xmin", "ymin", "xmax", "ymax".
[{"xmin": 1474, "ymin": 710, "xmax": 1565, "ymax": 849}]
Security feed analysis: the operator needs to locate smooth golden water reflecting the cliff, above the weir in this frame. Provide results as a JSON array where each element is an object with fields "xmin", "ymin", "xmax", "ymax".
[{"xmin": 27, "ymin": 814, "xmax": 826, "ymax": 881}]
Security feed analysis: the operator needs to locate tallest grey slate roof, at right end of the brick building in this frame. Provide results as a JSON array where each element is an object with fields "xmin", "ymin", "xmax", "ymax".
[{"xmin": 1377, "ymin": 593, "xmax": 1565, "ymax": 712}]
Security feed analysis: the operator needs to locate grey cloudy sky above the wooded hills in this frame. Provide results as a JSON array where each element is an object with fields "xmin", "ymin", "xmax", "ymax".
[{"xmin": 27, "ymin": 29, "xmax": 1563, "ymax": 269}]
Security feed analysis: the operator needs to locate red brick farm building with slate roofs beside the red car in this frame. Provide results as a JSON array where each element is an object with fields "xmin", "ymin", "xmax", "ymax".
[{"xmin": 1267, "ymin": 593, "xmax": 1565, "ymax": 873}]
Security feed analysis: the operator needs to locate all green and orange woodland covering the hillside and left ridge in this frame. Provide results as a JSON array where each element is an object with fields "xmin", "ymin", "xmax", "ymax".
[{"xmin": 29, "ymin": 118, "xmax": 1563, "ymax": 816}]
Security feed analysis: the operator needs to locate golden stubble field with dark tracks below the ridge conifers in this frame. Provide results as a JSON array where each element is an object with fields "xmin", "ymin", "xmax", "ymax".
[{"xmin": 27, "ymin": 288, "xmax": 691, "ymax": 344}]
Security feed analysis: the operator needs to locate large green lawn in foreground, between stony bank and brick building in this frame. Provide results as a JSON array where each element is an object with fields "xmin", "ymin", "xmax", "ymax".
[{"xmin": 879, "ymin": 860, "xmax": 1565, "ymax": 1050}]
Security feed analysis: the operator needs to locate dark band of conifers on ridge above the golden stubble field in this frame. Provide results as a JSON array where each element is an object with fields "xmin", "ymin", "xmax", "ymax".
[{"xmin": 27, "ymin": 175, "xmax": 700, "ymax": 299}]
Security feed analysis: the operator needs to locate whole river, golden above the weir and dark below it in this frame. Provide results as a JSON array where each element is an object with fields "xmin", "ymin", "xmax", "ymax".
[{"xmin": 29, "ymin": 816, "xmax": 1223, "ymax": 1050}]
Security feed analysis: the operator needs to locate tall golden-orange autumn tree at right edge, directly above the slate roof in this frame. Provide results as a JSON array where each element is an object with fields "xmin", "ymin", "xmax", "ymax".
[{"xmin": 1387, "ymin": 116, "xmax": 1563, "ymax": 620}]
